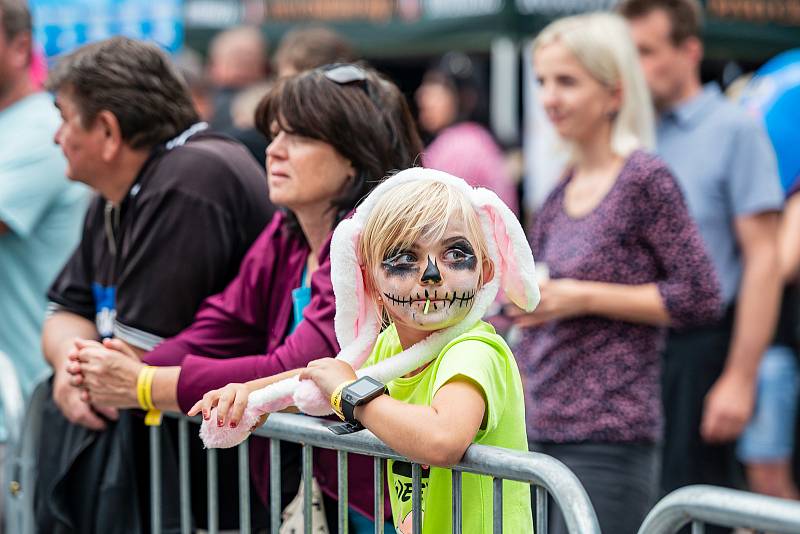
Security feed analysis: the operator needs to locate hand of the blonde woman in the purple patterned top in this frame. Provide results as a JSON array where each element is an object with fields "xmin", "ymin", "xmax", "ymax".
[{"xmin": 506, "ymin": 278, "xmax": 589, "ymax": 328}]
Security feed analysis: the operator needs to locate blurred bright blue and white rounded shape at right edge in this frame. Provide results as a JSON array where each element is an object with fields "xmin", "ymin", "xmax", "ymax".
[{"xmin": 741, "ymin": 48, "xmax": 800, "ymax": 191}]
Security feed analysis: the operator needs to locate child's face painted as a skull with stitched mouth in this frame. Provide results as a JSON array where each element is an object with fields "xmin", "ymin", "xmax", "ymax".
[{"xmin": 375, "ymin": 217, "xmax": 481, "ymax": 331}]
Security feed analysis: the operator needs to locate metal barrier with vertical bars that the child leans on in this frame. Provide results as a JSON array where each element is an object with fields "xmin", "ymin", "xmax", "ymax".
[{"xmin": 155, "ymin": 413, "xmax": 600, "ymax": 534}]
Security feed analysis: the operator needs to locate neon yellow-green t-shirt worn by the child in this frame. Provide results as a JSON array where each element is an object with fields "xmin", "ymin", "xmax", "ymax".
[{"xmin": 368, "ymin": 321, "xmax": 533, "ymax": 534}]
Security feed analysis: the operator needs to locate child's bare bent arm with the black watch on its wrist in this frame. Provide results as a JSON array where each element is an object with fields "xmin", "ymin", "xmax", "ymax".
[{"xmin": 300, "ymin": 358, "xmax": 486, "ymax": 466}]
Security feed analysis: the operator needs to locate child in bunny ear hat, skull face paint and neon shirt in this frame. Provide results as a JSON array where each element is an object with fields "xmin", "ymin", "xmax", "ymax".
[{"xmin": 190, "ymin": 168, "xmax": 539, "ymax": 534}]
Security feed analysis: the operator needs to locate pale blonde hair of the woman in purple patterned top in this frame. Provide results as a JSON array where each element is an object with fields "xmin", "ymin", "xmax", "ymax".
[{"xmin": 533, "ymin": 13, "xmax": 655, "ymax": 157}]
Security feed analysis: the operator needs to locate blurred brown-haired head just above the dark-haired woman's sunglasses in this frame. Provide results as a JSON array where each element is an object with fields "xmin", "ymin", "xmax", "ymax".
[{"xmin": 272, "ymin": 26, "xmax": 356, "ymax": 78}]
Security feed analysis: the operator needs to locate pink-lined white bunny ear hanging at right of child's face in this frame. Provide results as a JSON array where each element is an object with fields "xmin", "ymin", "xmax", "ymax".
[{"xmin": 472, "ymin": 188, "xmax": 539, "ymax": 311}]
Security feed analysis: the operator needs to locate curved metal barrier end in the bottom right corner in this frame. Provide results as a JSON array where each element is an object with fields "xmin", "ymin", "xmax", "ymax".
[{"xmin": 639, "ymin": 486, "xmax": 800, "ymax": 534}]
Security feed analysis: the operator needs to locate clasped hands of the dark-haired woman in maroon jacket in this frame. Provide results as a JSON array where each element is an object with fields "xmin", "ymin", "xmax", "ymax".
[{"xmin": 72, "ymin": 339, "xmax": 144, "ymax": 408}]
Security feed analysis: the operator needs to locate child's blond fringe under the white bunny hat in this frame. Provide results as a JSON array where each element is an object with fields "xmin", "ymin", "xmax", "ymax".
[{"xmin": 357, "ymin": 182, "xmax": 489, "ymax": 310}]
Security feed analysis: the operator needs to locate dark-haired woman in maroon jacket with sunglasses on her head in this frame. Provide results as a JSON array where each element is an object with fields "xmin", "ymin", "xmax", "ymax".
[{"xmin": 70, "ymin": 64, "xmax": 422, "ymax": 532}]
